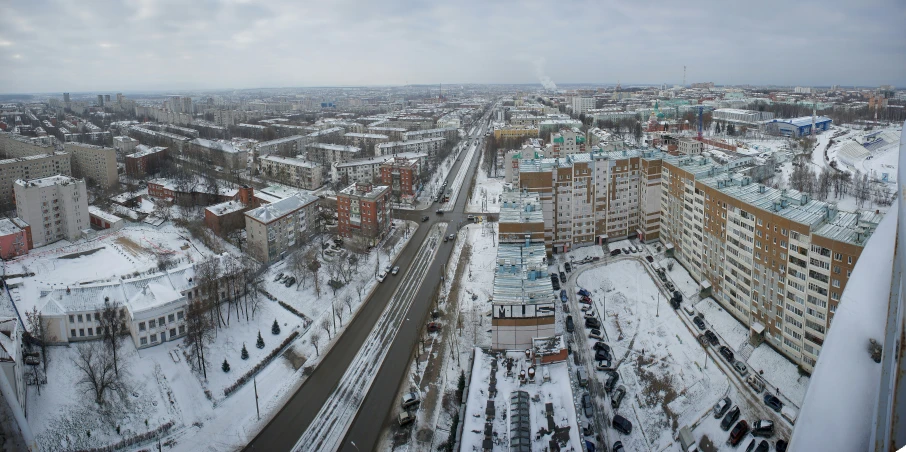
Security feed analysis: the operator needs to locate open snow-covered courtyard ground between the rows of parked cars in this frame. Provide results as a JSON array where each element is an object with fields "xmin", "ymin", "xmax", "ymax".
[{"xmin": 578, "ymin": 260, "xmax": 730, "ymax": 451}]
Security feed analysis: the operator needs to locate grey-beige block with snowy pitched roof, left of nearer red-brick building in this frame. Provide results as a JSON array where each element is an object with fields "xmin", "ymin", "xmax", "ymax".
[{"xmin": 245, "ymin": 193, "xmax": 319, "ymax": 263}]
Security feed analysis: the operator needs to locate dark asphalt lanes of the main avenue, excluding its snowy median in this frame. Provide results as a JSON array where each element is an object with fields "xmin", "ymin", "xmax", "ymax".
[{"xmin": 245, "ymin": 110, "xmax": 487, "ymax": 451}]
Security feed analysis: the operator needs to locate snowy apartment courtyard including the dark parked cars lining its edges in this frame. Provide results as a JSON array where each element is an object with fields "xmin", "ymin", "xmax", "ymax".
[{"xmin": 551, "ymin": 245, "xmax": 791, "ymax": 450}]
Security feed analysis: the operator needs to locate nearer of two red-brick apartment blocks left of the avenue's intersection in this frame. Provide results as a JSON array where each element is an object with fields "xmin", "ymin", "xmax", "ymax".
[{"xmin": 337, "ymin": 182, "xmax": 391, "ymax": 246}]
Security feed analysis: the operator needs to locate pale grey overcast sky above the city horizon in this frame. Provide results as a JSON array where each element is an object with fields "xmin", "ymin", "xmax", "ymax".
[{"xmin": 0, "ymin": 0, "xmax": 906, "ymax": 93}]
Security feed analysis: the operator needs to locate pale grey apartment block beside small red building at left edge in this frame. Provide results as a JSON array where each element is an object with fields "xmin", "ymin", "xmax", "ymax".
[{"xmin": 13, "ymin": 176, "xmax": 91, "ymax": 247}]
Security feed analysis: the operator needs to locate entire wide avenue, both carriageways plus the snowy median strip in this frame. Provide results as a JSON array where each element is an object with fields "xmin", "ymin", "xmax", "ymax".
[{"xmin": 245, "ymin": 107, "xmax": 489, "ymax": 451}]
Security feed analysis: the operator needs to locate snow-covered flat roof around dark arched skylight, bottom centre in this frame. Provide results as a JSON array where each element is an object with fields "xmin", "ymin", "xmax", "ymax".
[{"xmin": 460, "ymin": 349, "xmax": 580, "ymax": 452}]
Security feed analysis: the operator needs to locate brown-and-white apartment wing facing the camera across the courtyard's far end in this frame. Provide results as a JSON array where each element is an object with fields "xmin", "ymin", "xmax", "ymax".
[{"xmin": 519, "ymin": 150, "xmax": 662, "ymax": 253}]
